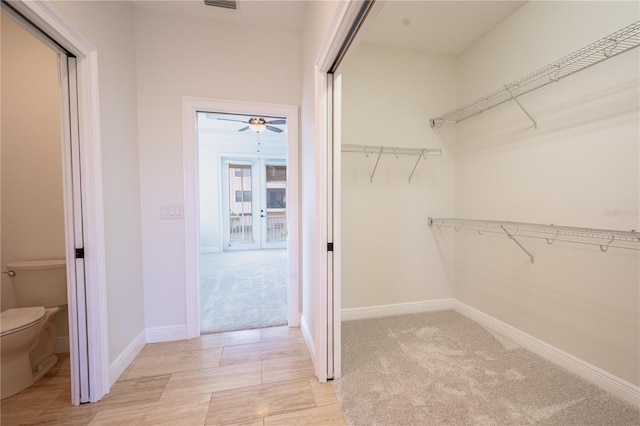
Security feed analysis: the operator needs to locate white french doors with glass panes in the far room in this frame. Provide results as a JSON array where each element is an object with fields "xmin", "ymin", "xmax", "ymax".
[{"xmin": 221, "ymin": 158, "xmax": 287, "ymax": 250}]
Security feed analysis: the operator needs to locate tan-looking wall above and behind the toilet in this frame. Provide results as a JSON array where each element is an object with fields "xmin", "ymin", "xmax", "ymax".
[{"xmin": 0, "ymin": 12, "xmax": 69, "ymax": 338}]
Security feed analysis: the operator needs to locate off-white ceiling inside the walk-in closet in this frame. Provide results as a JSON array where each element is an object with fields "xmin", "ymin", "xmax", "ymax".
[{"xmin": 363, "ymin": 0, "xmax": 526, "ymax": 56}]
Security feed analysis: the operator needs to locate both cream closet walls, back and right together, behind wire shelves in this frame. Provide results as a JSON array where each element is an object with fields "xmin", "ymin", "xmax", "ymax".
[{"xmin": 341, "ymin": 2, "xmax": 640, "ymax": 385}]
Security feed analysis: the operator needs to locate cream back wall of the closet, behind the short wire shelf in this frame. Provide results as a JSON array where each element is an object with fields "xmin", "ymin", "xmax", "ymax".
[{"xmin": 341, "ymin": 44, "xmax": 456, "ymax": 309}]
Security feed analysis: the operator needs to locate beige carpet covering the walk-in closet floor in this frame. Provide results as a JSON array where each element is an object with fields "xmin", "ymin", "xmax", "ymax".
[{"xmin": 333, "ymin": 311, "xmax": 640, "ymax": 426}]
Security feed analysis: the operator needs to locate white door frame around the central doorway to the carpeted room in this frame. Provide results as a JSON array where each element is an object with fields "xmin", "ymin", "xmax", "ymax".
[{"xmin": 182, "ymin": 96, "xmax": 302, "ymax": 339}]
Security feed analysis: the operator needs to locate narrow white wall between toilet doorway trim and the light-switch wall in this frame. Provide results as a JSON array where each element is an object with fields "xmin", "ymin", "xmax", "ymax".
[{"xmin": 51, "ymin": 1, "xmax": 145, "ymax": 362}]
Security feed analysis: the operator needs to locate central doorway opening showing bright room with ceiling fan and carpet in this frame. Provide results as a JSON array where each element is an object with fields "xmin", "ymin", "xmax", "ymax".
[{"xmin": 196, "ymin": 110, "xmax": 291, "ymax": 333}]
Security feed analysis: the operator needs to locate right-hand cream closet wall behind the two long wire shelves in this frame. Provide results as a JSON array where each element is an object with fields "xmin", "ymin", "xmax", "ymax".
[{"xmin": 452, "ymin": 2, "xmax": 640, "ymax": 385}]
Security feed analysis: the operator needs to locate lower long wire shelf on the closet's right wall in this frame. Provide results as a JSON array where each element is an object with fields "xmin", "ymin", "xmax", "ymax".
[{"xmin": 429, "ymin": 217, "xmax": 640, "ymax": 263}]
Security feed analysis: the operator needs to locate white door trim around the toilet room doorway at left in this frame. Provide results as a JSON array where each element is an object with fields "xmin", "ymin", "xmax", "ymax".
[{"xmin": 11, "ymin": 0, "xmax": 110, "ymax": 405}]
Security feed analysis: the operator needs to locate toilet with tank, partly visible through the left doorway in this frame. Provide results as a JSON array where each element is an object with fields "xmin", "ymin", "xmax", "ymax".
[{"xmin": 0, "ymin": 259, "xmax": 67, "ymax": 399}]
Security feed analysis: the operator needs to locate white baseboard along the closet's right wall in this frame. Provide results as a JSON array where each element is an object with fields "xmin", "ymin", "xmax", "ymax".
[{"xmin": 453, "ymin": 299, "xmax": 640, "ymax": 407}]
